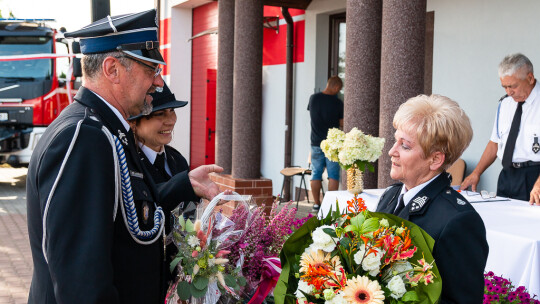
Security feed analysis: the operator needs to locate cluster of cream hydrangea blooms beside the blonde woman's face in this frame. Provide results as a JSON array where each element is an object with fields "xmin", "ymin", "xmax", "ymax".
[{"xmin": 321, "ymin": 128, "xmax": 385, "ymax": 171}]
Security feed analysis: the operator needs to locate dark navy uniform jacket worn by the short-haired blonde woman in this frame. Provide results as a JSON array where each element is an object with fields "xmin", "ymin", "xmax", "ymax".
[{"xmin": 377, "ymin": 172, "xmax": 488, "ymax": 304}]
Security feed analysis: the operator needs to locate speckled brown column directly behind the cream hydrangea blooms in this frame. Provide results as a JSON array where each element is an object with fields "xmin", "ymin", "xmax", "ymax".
[{"xmin": 343, "ymin": 0, "xmax": 382, "ymax": 189}]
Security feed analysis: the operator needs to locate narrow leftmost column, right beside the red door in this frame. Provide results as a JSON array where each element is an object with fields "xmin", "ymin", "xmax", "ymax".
[{"xmin": 216, "ymin": 0, "xmax": 234, "ymax": 174}]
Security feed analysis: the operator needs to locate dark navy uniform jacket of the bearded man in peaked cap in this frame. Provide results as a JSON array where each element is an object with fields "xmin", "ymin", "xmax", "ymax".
[{"xmin": 27, "ymin": 87, "xmax": 196, "ymax": 304}]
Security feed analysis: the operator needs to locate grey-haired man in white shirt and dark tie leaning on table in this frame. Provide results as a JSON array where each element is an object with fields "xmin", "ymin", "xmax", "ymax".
[{"xmin": 461, "ymin": 53, "xmax": 540, "ymax": 206}]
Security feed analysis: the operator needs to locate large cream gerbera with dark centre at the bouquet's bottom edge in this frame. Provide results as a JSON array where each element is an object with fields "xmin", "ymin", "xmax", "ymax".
[{"xmin": 343, "ymin": 276, "xmax": 384, "ymax": 304}]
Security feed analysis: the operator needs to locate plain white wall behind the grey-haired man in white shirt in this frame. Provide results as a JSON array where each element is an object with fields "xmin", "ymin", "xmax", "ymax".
[{"xmin": 427, "ymin": 0, "xmax": 540, "ymax": 191}]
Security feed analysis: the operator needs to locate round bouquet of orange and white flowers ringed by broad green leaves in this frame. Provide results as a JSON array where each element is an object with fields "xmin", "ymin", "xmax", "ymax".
[{"xmin": 274, "ymin": 196, "xmax": 442, "ymax": 304}]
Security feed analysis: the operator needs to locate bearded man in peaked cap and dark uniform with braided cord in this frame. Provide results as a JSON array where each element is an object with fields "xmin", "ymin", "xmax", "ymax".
[{"xmin": 27, "ymin": 10, "xmax": 222, "ymax": 304}]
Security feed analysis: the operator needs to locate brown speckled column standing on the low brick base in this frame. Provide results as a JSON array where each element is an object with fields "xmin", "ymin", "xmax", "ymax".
[{"xmin": 231, "ymin": 0, "xmax": 263, "ymax": 178}]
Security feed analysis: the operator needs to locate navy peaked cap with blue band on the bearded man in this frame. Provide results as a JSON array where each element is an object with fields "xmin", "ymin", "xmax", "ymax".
[{"xmin": 64, "ymin": 9, "xmax": 166, "ymax": 65}]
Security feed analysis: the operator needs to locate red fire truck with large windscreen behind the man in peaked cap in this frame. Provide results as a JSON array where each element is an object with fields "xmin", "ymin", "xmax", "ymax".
[{"xmin": 0, "ymin": 19, "xmax": 75, "ymax": 166}]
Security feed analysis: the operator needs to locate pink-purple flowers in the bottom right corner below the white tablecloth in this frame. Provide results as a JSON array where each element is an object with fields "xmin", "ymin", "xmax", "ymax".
[{"xmin": 483, "ymin": 271, "xmax": 540, "ymax": 304}]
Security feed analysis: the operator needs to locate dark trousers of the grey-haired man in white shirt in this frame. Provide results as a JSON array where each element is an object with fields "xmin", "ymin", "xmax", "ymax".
[{"xmin": 497, "ymin": 166, "xmax": 540, "ymax": 201}]
